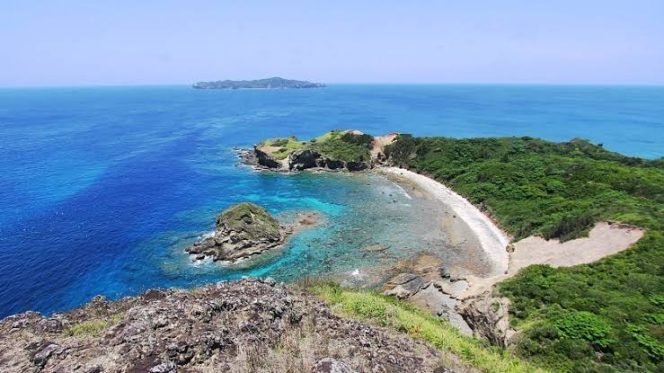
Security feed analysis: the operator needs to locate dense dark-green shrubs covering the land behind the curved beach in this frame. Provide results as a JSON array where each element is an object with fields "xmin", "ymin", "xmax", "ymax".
[{"xmin": 386, "ymin": 135, "xmax": 664, "ymax": 372}]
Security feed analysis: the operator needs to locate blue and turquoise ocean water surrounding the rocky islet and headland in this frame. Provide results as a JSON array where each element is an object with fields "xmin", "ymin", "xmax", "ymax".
[{"xmin": 0, "ymin": 85, "xmax": 664, "ymax": 317}]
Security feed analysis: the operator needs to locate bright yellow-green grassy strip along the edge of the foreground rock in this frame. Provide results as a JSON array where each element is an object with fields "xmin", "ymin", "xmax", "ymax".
[{"xmin": 311, "ymin": 284, "xmax": 544, "ymax": 372}]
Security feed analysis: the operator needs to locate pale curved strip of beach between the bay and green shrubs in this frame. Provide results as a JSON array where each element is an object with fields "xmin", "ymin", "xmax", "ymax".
[{"xmin": 376, "ymin": 167, "xmax": 510, "ymax": 276}]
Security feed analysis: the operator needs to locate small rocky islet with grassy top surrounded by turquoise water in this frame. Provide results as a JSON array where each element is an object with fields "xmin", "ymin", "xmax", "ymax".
[{"xmin": 185, "ymin": 202, "xmax": 318, "ymax": 262}]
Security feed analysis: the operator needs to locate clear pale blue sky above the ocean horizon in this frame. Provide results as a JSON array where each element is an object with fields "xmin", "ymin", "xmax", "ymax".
[{"xmin": 0, "ymin": 0, "xmax": 664, "ymax": 86}]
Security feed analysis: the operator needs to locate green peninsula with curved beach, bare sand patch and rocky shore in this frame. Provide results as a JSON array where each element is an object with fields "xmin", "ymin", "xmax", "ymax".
[{"xmin": 249, "ymin": 130, "xmax": 664, "ymax": 371}]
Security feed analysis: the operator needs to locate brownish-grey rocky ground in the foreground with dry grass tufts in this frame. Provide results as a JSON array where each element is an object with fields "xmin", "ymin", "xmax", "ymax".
[{"xmin": 0, "ymin": 280, "xmax": 449, "ymax": 373}]
